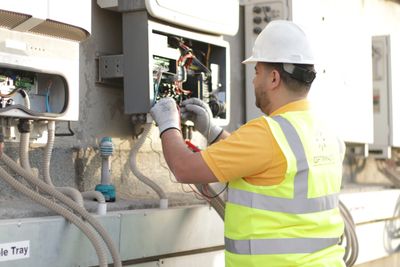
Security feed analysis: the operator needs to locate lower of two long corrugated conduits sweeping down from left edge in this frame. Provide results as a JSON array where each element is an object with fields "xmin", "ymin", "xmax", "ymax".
[{"xmin": 0, "ymin": 167, "xmax": 108, "ymax": 267}]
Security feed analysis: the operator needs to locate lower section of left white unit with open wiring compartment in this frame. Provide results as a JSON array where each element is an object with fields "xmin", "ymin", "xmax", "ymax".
[{"xmin": 0, "ymin": 26, "xmax": 79, "ymax": 120}]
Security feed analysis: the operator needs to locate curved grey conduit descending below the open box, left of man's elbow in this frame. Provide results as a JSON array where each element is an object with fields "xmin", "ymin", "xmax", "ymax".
[{"xmin": 129, "ymin": 123, "xmax": 168, "ymax": 209}]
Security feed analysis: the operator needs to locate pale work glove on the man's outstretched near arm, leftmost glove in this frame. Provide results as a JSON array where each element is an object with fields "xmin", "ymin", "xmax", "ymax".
[{"xmin": 150, "ymin": 97, "xmax": 181, "ymax": 137}]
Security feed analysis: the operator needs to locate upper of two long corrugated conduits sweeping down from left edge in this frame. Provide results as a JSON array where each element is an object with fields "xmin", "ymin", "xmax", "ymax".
[{"xmin": 0, "ymin": 153, "xmax": 122, "ymax": 267}]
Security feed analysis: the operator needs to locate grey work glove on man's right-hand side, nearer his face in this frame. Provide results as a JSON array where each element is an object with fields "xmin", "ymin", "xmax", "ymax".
[{"xmin": 181, "ymin": 98, "xmax": 223, "ymax": 144}]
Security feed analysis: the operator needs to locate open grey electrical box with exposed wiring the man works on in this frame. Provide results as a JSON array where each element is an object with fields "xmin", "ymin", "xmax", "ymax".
[{"xmin": 123, "ymin": 11, "xmax": 230, "ymax": 125}]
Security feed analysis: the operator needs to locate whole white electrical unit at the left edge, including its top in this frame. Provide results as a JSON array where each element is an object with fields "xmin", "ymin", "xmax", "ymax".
[{"xmin": 0, "ymin": 0, "xmax": 91, "ymax": 120}]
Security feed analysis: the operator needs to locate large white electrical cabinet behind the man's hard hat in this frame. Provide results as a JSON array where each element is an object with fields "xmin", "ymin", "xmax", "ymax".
[{"xmin": 244, "ymin": 0, "xmax": 373, "ymax": 144}]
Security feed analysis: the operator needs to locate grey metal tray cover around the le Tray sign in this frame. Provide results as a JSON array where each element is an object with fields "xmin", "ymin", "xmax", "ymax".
[{"xmin": 0, "ymin": 215, "xmax": 120, "ymax": 267}]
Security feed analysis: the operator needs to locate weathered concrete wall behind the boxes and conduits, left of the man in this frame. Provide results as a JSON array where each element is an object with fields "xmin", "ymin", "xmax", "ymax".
[{"xmin": 0, "ymin": 1, "xmax": 244, "ymax": 206}]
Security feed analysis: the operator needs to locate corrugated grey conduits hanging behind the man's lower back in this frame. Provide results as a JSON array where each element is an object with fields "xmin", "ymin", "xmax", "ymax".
[{"xmin": 339, "ymin": 201, "xmax": 359, "ymax": 267}]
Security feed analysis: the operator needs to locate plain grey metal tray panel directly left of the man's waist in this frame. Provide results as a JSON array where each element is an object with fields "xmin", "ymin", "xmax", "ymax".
[{"xmin": 121, "ymin": 206, "xmax": 224, "ymax": 260}]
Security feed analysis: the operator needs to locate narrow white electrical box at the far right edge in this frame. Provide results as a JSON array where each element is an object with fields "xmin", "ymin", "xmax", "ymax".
[{"xmin": 364, "ymin": 1, "xmax": 400, "ymax": 155}]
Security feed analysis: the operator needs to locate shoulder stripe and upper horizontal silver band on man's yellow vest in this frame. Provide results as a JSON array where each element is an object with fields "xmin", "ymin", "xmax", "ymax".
[{"xmin": 228, "ymin": 116, "xmax": 339, "ymax": 214}]
